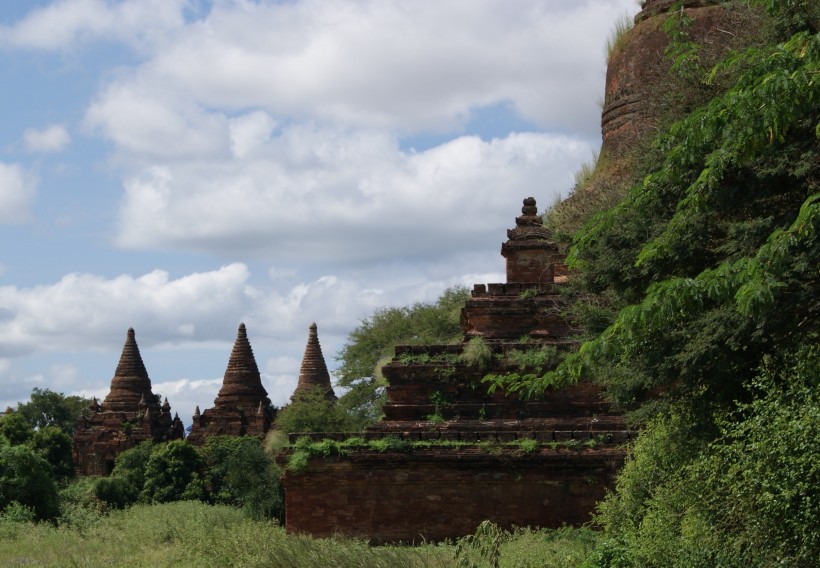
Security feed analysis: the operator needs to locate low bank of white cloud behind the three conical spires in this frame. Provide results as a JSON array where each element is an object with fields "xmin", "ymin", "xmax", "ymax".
[{"xmin": 0, "ymin": 258, "xmax": 500, "ymax": 422}]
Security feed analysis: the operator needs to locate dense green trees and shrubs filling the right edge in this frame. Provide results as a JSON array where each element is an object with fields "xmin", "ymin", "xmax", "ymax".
[{"xmin": 540, "ymin": 0, "xmax": 820, "ymax": 566}]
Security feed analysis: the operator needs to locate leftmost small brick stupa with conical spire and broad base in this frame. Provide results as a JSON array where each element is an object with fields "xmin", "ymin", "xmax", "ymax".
[{"xmin": 73, "ymin": 328, "xmax": 184, "ymax": 475}]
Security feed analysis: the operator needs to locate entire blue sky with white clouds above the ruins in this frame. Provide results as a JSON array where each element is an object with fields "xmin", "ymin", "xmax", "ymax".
[{"xmin": 0, "ymin": 0, "xmax": 639, "ymax": 424}]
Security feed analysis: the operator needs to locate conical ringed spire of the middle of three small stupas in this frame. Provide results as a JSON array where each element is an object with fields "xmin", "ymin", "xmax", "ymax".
[{"xmin": 214, "ymin": 323, "xmax": 270, "ymax": 413}]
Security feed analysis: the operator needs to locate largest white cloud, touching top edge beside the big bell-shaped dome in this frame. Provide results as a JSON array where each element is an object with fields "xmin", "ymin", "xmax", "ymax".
[{"xmin": 81, "ymin": 0, "xmax": 637, "ymax": 142}]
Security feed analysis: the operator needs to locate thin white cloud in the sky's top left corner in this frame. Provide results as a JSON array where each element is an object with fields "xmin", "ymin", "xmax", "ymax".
[{"xmin": 0, "ymin": 0, "xmax": 188, "ymax": 51}]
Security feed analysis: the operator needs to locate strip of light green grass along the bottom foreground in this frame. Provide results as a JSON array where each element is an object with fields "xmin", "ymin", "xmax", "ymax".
[{"xmin": 0, "ymin": 501, "xmax": 597, "ymax": 568}]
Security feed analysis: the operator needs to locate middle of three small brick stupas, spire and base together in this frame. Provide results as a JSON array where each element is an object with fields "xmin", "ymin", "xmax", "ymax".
[{"xmin": 188, "ymin": 323, "xmax": 275, "ymax": 445}]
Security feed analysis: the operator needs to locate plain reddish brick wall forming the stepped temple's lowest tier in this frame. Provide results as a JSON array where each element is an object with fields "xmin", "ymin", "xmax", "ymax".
[{"xmin": 284, "ymin": 448, "xmax": 623, "ymax": 543}]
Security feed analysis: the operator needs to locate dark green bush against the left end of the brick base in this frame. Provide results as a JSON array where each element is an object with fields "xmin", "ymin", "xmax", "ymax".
[{"xmin": 202, "ymin": 436, "xmax": 284, "ymax": 519}]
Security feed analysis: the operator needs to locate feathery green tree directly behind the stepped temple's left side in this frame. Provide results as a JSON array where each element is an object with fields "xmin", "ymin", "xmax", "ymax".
[{"xmin": 334, "ymin": 288, "xmax": 469, "ymax": 424}]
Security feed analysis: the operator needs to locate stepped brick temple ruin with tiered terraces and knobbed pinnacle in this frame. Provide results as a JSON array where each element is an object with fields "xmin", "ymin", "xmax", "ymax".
[{"xmin": 279, "ymin": 198, "xmax": 630, "ymax": 543}]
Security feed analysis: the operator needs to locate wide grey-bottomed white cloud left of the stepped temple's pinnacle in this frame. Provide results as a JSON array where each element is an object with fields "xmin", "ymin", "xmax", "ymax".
[{"xmin": 118, "ymin": 126, "xmax": 590, "ymax": 263}]
